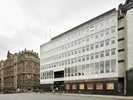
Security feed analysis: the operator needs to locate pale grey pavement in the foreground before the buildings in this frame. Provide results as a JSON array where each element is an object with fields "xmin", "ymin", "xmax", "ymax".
[{"xmin": 0, "ymin": 93, "xmax": 133, "ymax": 100}]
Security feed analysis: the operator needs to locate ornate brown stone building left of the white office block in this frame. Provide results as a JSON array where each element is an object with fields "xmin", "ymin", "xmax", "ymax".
[{"xmin": 0, "ymin": 49, "xmax": 40, "ymax": 92}]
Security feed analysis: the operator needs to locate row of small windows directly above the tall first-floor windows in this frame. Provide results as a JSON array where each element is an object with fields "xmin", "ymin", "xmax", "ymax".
[{"xmin": 41, "ymin": 48, "xmax": 116, "ymax": 69}]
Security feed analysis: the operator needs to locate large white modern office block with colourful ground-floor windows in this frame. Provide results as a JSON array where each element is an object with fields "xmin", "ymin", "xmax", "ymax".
[{"xmin": 40, "ymin": 0, "xmax": 133, "ymax": 95}]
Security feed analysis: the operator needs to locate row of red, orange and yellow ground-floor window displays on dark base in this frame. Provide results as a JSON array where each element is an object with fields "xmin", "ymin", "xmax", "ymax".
[{"xmin": 65, "ymin": 82, "xmax": 115, "ymax": 91}]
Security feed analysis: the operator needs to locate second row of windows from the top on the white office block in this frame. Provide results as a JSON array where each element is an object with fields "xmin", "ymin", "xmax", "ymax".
[{"xmin": 43, "ymin": 26, "xmax": 116, "ymax": 54}]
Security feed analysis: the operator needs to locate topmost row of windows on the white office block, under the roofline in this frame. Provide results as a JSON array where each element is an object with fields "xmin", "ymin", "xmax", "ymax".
[{"xmin": 44, "ymin": 15, "xmax": 116, "ymax": 50}]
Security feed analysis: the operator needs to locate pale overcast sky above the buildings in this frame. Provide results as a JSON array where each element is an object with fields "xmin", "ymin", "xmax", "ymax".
[{"xmin": 0, "ymin": 0, "xmax": 125, "ymax": 60}]
